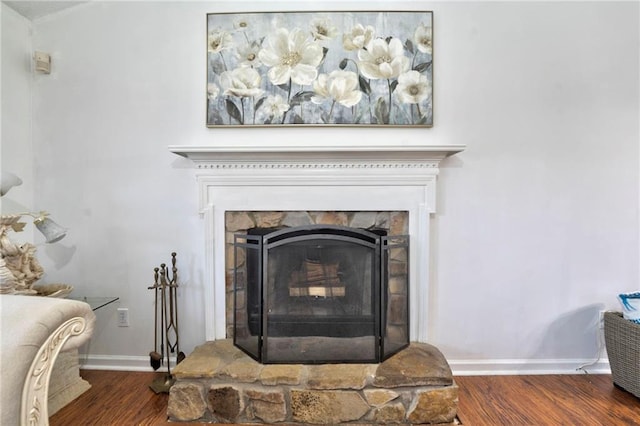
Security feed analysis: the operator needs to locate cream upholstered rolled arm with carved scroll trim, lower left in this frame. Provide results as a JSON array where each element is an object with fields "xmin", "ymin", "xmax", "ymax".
[{"xmin": 0, "ymin": 295, "xmax": 95, "ymax": 426}]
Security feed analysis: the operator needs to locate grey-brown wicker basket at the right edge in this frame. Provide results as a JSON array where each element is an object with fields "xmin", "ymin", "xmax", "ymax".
[{"xmin": 604, "ymin": 312, "xmax": 640, "ymax": 398}]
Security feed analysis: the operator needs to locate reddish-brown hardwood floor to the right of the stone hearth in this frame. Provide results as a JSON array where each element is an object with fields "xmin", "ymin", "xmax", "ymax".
[{"xmin": 455, "ymin": 374, "xmax": 640, "ymax": 426}]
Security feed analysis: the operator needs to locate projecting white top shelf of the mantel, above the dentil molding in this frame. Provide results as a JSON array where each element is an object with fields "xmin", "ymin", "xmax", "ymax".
[{"xmin": 169, "ymin": 145, "xmax": 466, "ymax": 163}]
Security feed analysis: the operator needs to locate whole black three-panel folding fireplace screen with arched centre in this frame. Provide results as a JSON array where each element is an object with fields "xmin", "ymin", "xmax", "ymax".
[{"xmin": 234, "ymin": 225, "xmax": 409, "ymax": 363}]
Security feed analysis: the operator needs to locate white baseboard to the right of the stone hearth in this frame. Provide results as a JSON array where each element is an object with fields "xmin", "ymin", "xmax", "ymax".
[{"xmin": 448, "ymin": 359, "xmax": 611, "ymax": 376}]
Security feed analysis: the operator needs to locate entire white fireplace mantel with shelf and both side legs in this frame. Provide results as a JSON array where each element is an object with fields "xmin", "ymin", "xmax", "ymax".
[{"xmin": 169, "ymin": 145, "xmax": 465, "ymax": 342}]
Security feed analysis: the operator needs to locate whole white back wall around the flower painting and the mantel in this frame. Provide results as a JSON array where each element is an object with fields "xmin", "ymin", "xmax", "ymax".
[{"xmin": 3, "ymin": 1, "xmax": 640, "ymax": 371}]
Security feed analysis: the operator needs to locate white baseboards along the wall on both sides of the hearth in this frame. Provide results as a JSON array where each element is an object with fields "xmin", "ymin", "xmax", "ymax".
[{"xmin": 80, "ymin": 355, "xmax": 611, "ymax": 376}]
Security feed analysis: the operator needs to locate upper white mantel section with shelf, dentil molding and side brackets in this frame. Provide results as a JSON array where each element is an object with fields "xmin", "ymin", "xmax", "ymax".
[{"xmin": 169, "ymin": 145, "xmax": 466, "ymax": 214}]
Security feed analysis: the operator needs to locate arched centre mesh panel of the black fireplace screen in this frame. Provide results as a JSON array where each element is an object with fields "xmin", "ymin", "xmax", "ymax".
[{"xmin": 265, "ymin": 238, "xmax": 379, "ymax": 362}]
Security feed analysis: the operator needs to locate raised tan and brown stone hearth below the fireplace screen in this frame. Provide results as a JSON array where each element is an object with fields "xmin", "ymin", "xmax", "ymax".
[{"xmin": 168, "ymin": 339, "xmax": 458, "ymax": 424}]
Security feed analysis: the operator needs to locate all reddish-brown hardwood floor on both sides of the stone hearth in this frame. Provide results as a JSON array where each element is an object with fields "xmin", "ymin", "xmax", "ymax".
[{"xmin": 49, "ymin": 370, "xmax": 640, "ymax": 426}]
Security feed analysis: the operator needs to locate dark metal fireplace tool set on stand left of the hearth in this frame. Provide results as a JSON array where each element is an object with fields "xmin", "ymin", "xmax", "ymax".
[{"xmin": 148, "ymin": 253, "xmax": 185, "ymax": 393}]
